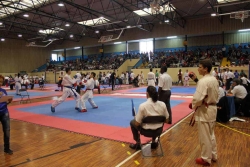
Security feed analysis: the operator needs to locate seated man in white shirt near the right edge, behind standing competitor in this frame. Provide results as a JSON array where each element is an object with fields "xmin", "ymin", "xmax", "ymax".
[{"xmin": 228, "ymin": 79, "xmax": 247, "ymax": 111}]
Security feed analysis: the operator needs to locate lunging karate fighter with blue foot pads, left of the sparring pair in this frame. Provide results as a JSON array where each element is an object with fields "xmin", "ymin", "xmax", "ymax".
[{"xmin": 51, "ymin": 68, "xmax": 81, "ymax": 113}]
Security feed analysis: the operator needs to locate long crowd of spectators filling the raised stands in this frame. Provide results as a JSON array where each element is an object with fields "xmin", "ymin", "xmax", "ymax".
[{"xmin": 41, "ymin": 44, "xmax": 250, "ymax": 71}]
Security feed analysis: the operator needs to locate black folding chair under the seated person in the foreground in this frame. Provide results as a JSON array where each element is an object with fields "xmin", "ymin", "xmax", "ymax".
[{"xmin": 138, "ymin": 116, "xmax": 166, "ymax": 157}]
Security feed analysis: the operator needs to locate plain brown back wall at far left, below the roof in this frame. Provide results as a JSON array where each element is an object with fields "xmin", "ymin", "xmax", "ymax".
[{"xmin": 0, "ymin": 39, "xmax": 52, "ymax": 73}]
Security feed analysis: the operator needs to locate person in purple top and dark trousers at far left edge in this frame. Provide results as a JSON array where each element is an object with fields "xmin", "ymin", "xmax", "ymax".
[{"xmin": 0, "ymin": 75, "xmax": 13, "ymax": 155}]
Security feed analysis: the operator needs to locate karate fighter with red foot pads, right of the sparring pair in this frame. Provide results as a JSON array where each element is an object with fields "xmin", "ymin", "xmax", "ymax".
[{"xmin": 81, "ymin": 72, "xmax": 98, "ymax": 112}]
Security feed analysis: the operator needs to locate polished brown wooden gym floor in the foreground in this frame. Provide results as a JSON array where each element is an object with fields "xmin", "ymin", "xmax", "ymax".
[{"xmin": 0, "ymin": 87, "xmax": 250, "ymax": 167}]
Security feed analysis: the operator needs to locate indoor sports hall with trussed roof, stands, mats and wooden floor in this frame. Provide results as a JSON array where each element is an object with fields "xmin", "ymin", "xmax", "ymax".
[{"xmin": 0, "ymin": 0, "xmax": 250, "ymax": 167}]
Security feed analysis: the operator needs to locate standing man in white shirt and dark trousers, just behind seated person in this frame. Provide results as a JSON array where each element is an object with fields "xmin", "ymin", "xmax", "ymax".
[{"xmin": 158, "ymin": 66, "xmax": 172, "ymax": 124}]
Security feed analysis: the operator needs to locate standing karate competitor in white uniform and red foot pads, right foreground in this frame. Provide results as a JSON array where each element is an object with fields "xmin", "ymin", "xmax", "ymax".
[{"xmin": 192, "ymin": 59, "xmax": 219, "ymax": 166}]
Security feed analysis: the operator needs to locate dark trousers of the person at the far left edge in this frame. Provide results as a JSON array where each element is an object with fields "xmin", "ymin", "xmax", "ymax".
[{"xmin": 0, "ymin": 112, "xmax": 10, "ymax": 150}]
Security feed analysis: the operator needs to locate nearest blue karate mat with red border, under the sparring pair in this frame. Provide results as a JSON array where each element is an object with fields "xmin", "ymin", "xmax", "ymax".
[{"xmin": 9, "ymin": 96, "xmax": 191, "ymax": 143}]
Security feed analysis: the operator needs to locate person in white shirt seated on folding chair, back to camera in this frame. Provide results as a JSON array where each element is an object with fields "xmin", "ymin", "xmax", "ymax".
[{"xmin": 129, "ymin": 86, "xmax": 169, "ymax": 149}]
